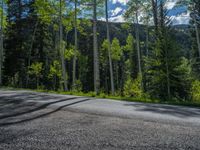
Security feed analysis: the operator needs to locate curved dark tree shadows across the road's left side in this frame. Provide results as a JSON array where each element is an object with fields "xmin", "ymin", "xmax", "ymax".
[{"xmin": 0, "ymin": 93, "xmax": 90, "ymax": 126}]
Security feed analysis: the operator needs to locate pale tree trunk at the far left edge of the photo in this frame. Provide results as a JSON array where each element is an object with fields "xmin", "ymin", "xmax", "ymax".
[{"xmin": 0, "ymin": 0, "xmax": 4, "ymax": 86}]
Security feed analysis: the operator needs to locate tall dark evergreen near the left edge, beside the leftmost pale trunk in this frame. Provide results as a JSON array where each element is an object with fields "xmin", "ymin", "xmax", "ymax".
[{"xmin": 4, "ymin": 0, "xmax": 35, "ymax": 87}]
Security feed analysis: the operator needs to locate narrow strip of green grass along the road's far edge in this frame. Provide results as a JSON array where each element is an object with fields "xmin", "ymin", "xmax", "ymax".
[{"xmin": 1, "ymin": 87, "xmax": 200, "ymax": 108}]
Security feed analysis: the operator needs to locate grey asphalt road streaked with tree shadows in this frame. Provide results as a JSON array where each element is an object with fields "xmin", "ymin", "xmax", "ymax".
[{"xmin": 0, "ymin": 90, "xmax": 200, "ymax": 150}]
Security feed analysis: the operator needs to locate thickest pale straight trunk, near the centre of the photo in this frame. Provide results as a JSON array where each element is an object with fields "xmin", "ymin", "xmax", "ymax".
[{"xmin": 93, "ymin": 0, "xmax": 100, "ymax": 94}]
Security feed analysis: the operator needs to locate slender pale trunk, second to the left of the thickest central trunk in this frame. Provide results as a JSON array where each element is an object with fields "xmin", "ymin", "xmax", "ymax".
[{"xmin": 59, "ymin": 0, "xmax": 68, "ymax": 91}]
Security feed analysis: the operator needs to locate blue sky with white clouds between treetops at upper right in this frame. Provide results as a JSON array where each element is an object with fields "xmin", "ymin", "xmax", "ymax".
[{"xmin": 109, "ymin": 0, "xmax": 190, "ymax": 25}]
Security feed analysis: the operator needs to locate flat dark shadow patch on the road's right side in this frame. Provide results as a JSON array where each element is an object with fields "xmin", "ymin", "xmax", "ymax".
[{"xmin": 125, "ymin": 103, "xmax": 200, "ymax": 118}]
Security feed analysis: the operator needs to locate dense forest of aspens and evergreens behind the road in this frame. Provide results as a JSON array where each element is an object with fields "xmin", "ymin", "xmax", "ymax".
[{"xmin": 0, "ymin": 0, "xmax": 200, "ymax": 101}]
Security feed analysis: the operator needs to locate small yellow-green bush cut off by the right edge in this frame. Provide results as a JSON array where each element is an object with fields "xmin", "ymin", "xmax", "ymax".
[{"xmin": 191, "ymin": 80, "xmax": 200, "ymax": 102}]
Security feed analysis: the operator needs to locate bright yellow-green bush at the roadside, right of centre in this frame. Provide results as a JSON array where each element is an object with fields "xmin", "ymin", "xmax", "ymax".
[{"xmin": 124, "ymin": 75, "xmax": 143, "ymax": 98}]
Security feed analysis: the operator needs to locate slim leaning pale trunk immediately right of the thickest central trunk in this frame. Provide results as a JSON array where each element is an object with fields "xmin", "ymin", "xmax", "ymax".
[{"xmin": 105, "ymin": 0, "xmax": 115, "ymax": 95}]
